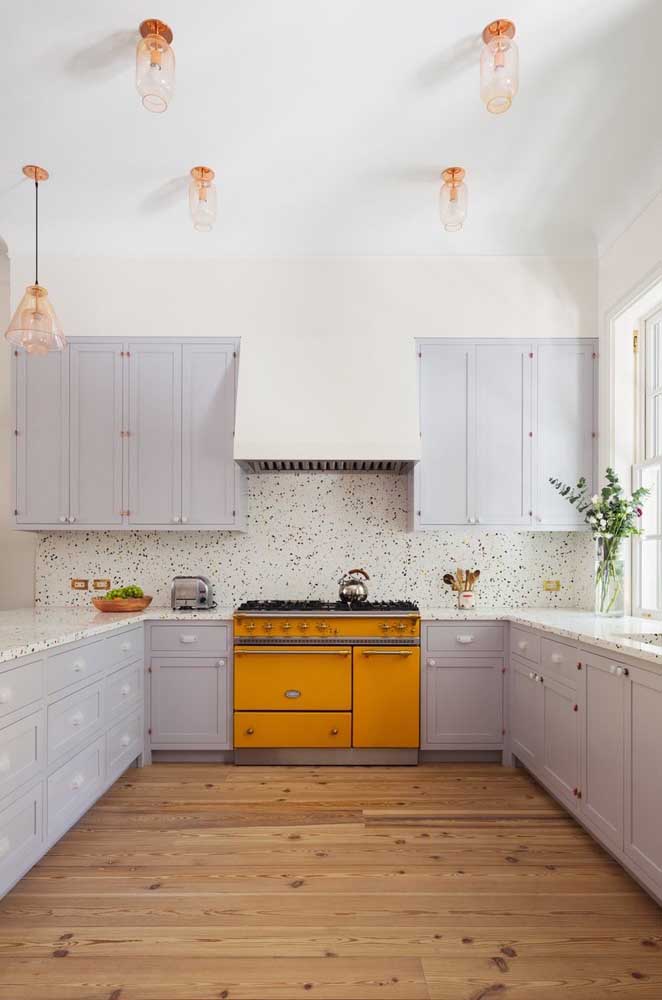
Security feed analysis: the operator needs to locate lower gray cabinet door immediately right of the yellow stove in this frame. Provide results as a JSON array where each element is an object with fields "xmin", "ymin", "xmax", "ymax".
[{"xmin": 421, "ymin": 656, "xmax": 503, "ymax": 749}]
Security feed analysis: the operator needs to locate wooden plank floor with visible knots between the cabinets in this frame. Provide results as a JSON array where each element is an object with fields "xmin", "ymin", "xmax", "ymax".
[{"xmin": 0, "ymin": 764, "xmax": 662, "ymax": 1000}]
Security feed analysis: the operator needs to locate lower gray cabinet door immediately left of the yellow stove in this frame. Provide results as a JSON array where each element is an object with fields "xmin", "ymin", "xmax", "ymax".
[{"xmin": 150, "ymin": 657, "xmax": 230, "ymax": 749}]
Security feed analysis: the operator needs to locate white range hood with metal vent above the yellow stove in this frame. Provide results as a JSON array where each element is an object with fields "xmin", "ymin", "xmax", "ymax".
[{"xmin": 234, "ymin": 331, "xmax": 421, "ymax": 472}]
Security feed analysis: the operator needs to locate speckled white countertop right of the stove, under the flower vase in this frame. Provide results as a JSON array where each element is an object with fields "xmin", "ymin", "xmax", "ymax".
[{"xmin": 421, "ymin": 608, "xmax": 662, "ymax": 664}]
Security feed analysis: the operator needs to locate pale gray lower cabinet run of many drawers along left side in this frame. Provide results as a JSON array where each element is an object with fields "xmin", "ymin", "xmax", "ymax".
[{"xmin": 0, "ymin": 624, "xmax": 144, "ymax": 896}]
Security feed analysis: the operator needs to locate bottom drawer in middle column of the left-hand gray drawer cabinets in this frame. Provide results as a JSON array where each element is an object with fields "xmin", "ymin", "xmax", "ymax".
[{"xmin": 47, "ymin": 736, "xmax": 106, "ymax": 840}]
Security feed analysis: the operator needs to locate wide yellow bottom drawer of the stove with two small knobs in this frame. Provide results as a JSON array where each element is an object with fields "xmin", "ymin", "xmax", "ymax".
[{"xmin": 234, "ymin": 712, "xmax": 352, "ymax": 747}]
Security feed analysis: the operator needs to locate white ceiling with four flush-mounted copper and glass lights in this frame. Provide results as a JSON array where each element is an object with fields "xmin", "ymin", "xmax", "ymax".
[{"xmin": 0, "ymin": 0, "xmax": 662, "ymax": 256}]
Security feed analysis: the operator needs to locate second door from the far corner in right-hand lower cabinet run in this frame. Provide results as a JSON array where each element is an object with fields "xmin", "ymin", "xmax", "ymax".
[{"xmin": 539, "ymin": 677, "xmax": 580, "ymax": 810}]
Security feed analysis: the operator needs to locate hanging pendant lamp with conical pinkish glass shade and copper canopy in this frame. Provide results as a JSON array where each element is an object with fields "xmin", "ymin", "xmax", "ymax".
[{"xmin": 5, "ymin": 164, "xmax": 67, "ymax": 354}]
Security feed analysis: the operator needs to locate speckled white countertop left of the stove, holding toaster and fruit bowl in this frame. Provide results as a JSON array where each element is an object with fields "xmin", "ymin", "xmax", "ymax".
[{"xmin": 0, "ymin": 607, "xmax": 234, "ymax": 663}]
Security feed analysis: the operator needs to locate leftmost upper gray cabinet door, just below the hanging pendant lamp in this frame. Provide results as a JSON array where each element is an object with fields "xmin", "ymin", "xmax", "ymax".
[{"xmin": 14, "ymin": 351, "xmax": 69, "ymax": 525}]
